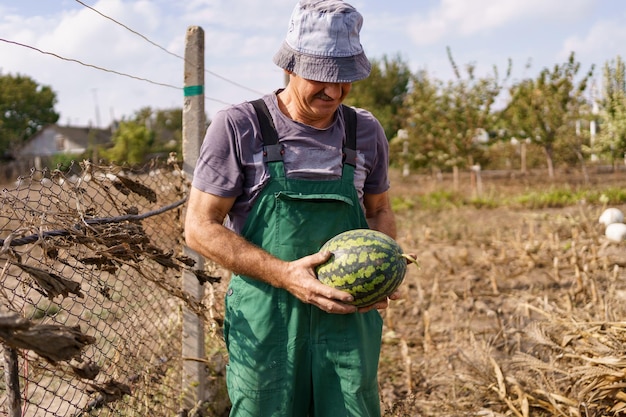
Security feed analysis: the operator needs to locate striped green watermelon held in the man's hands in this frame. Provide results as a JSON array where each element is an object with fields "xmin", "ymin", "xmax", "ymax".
[{"xmin": 317, "ymin": 229, "xmax": 407, "ymax": 307}]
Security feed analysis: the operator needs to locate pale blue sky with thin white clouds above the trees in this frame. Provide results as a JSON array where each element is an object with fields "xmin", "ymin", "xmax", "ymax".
[{"xmin": 0, "ymin": 0, "xmax": 626, "ymax": 128}]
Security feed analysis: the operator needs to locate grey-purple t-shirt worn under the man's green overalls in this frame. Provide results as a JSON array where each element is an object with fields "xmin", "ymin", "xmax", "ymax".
[{"xmin": 192, "ymin": 93, "xmax": 389, "ymax": 232}]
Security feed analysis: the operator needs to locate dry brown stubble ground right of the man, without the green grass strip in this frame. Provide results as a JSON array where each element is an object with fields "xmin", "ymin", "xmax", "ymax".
[{"xmin": 379, "ymin": 168, "xmax": 626, "ymax": 417}]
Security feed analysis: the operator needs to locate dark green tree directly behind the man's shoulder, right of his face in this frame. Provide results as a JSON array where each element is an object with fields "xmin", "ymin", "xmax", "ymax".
[{"xmin": 346, "ymin": 56, "xmax": 411, "ymax": 138}]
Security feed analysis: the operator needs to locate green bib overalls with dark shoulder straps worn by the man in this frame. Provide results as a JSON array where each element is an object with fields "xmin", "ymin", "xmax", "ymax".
[{"xmin": 224, "ymin": 101, "xmax": 382, "ymax": 417}]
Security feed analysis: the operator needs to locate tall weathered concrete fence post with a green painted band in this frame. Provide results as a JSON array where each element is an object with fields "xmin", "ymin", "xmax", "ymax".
[{"xmin": 182, "ymin": 26, "xmax": 207, "ymax": 410}]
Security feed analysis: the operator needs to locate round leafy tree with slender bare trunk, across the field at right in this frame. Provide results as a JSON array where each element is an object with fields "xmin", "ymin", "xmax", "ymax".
[{"xmin": 502, "ymin": 52, "xmax": 593, "ymax": 178}]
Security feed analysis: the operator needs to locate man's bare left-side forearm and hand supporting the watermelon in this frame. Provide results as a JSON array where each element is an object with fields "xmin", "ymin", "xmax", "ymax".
[{"xmin": 185, "ymin": 187, "xmax": 356, "ymax": 314}]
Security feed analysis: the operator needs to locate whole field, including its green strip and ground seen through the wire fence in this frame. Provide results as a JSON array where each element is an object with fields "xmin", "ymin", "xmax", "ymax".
[{"xmin": 6, "ymin": 163, "xmax": 626, "ymax": 417}]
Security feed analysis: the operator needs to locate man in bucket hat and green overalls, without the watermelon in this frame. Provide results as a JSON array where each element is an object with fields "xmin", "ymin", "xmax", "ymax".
[{"xmin": 185, "ymin": 0, "xmax": 395, "ymax": 417}]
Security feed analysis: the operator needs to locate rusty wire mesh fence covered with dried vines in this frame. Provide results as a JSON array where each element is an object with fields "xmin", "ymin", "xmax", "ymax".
[{"xmin": 0, "ymin": 158, "xmax": 219, "ymax": 417}]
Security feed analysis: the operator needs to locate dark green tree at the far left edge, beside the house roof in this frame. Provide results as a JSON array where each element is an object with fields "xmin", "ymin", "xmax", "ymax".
[{"xmin": 0, "ymin": 74, "xmax": 59, "ymax": 157}]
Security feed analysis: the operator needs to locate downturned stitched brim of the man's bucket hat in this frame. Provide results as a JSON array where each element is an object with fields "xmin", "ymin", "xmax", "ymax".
[{"xmin": 273, "ymin": 42, "xmax": 372, "ymax": 83}]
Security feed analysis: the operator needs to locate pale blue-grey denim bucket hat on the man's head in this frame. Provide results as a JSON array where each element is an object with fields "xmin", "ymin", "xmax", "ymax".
[{"xmin": 274, "ymin": 0, "xmax": 372, "ymax": 83}]
